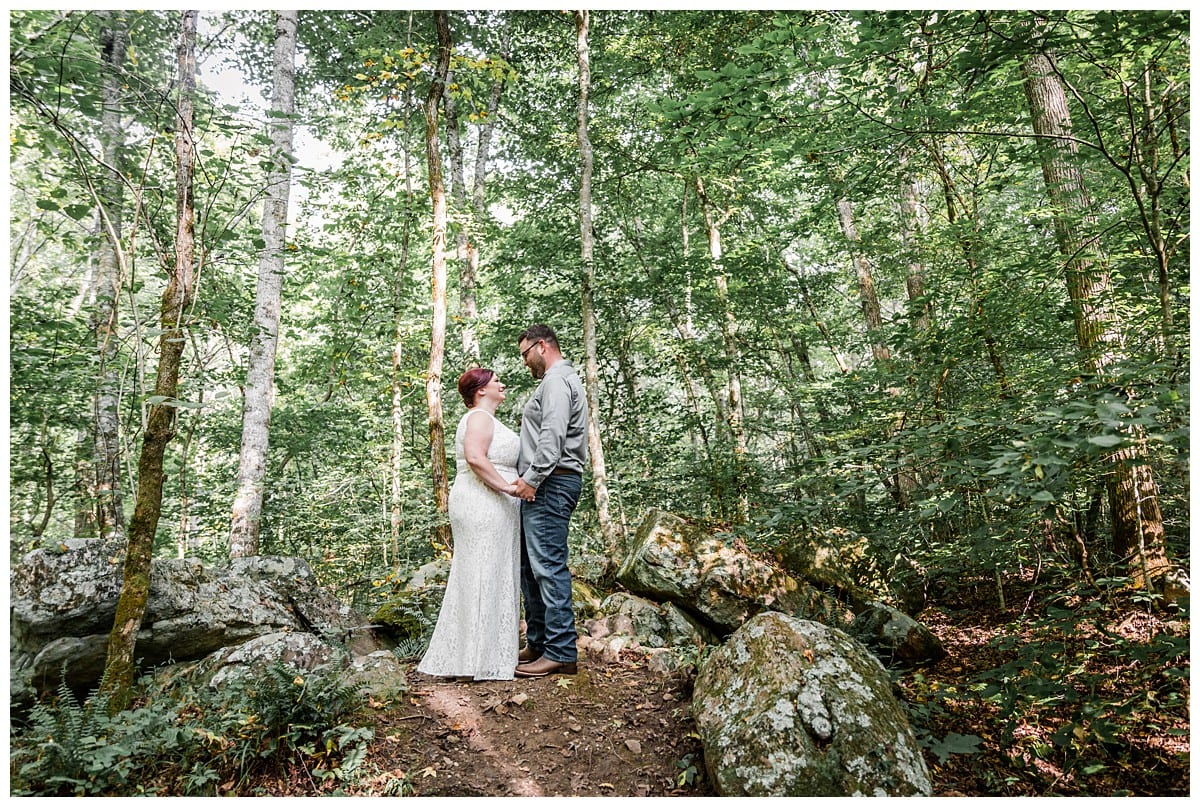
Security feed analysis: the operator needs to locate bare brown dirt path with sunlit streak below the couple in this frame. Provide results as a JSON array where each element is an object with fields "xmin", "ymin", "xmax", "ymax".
[{"xmin": 350, "ymin": 653, "xmax": 712, "ymax": 796}]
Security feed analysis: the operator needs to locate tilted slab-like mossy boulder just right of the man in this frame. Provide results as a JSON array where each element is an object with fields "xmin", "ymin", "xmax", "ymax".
[{"xmin": 617, "ymin": 510, "xmax": 851, "ymax": 635}]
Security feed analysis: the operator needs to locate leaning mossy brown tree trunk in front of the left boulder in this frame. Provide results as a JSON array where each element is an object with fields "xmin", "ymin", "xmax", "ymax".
[{"xmin": 100, "ymin": 11, "xmax": 198, "ymax": 712}]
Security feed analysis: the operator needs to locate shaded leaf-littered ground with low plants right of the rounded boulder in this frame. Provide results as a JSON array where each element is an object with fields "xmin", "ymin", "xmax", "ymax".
[{"xmin": 898, "ymin": 580, "xmax": 1190, "ymax": 796}]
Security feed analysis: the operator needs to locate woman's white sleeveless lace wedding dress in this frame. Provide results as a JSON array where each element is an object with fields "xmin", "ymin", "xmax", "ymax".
[{"xmin": 416, "ymin": 410, "xmax": 521, "ymax": 680}]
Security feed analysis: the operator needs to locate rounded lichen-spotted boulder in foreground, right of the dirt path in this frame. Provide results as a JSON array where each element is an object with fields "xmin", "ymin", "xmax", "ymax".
[{"xmin": 692, "ymin": 611, "xmax": 932, "ymax": 796}]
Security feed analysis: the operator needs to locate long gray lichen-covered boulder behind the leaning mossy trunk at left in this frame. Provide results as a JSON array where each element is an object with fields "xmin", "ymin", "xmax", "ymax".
[{"xmin": 10, "ymin": 540, "xmax": 379, "ymax": 701}]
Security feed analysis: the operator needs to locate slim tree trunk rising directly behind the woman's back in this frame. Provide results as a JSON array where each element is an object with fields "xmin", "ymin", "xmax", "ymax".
[{"xmin": 425, "ymin": 11, "xmax": 452, "ymax": 549}]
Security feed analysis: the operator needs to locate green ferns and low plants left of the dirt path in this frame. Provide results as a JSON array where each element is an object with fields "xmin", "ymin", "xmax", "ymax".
[{"xmin": 12, "ymin": 662, "xmax": 373, "ymax": 795}]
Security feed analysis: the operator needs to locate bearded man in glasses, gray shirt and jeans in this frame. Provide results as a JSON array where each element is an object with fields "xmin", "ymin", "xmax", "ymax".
[{"xmin": 516, "ymin": 324, "xmax": 588, "ymax": 679}]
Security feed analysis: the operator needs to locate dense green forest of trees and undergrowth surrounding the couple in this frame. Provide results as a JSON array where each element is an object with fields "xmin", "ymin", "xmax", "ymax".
[{"xmin": 7, "ymin": 10, "xmax": 1190, "ymax": 796}]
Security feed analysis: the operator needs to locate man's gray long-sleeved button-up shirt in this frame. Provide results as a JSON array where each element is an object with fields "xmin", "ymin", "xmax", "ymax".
[{"xmin": 517, "ymin": 359, "xmax": 588, "ymax": 488}]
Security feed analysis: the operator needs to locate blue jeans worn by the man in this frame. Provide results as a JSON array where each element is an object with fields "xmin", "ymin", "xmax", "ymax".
[{"xmin": 521, "ymin": 474, "xmax": 583, "ymax": 662}]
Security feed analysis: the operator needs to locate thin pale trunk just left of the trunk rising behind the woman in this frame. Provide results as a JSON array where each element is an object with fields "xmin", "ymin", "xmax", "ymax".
[{"xmin": 389, "ymin": 12, "xmax": 415, "ymax": 568}]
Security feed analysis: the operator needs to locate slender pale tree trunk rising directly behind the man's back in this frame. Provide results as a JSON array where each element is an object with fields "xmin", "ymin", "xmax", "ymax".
[{"xmin": 575, "ymin": 11, "xmax": 624, "ymax": 571}]
